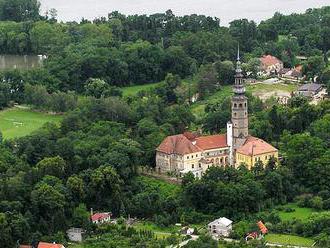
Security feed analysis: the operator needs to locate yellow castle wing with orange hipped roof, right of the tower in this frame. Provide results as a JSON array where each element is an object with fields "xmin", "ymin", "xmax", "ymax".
[{"xmin": 236, "ymin": 136, "xmax": 278, "ymax": 169}]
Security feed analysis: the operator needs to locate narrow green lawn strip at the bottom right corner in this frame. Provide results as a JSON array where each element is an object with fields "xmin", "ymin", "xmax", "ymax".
[{"xmin": 265, "ymin": 234, "xmax": 314, "ymax": 247}]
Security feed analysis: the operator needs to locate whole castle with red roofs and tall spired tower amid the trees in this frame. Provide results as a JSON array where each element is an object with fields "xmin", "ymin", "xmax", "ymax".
[{"xmin": 156, "ymin": 48, "xmax": 278, "ymax": 178}]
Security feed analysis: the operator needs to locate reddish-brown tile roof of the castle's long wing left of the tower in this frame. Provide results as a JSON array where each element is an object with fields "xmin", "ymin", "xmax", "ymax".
[{"xmin": 156, "ymin": 133, "xmax": 228, "ymax": 155}]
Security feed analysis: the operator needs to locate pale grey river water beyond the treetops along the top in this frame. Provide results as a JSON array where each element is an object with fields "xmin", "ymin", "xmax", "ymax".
[{"xmin": 39, "ymin": 0, "xmax": 330, "ymax": 26}]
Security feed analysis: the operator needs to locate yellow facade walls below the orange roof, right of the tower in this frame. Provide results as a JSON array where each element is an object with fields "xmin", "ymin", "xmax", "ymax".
[{"xmin": 236, "ymin": 151, "xmax": 278, "ymax": 169}]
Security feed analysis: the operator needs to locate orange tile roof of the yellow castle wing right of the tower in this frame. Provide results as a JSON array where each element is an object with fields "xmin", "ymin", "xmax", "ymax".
[{"xmin": 237, "ymin": 136, "xmax": 277, "ymax": 156}]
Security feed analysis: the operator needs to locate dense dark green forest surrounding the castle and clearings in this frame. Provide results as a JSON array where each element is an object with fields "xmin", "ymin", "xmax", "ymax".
[{"xmin": 0, "ymin": 0, "xmax": 330, "ymax": 248}]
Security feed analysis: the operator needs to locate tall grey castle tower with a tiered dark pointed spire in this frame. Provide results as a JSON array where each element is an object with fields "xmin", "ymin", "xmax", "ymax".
[{"xmin": 231, "ymin": 48, "xmax": 249, "ymax": 149}]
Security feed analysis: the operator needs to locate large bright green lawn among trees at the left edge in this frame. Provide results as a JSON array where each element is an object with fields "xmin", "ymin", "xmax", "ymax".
[{"xmin": 0, "ymin": 107, "xmax": 62, "ymax": 139}]
